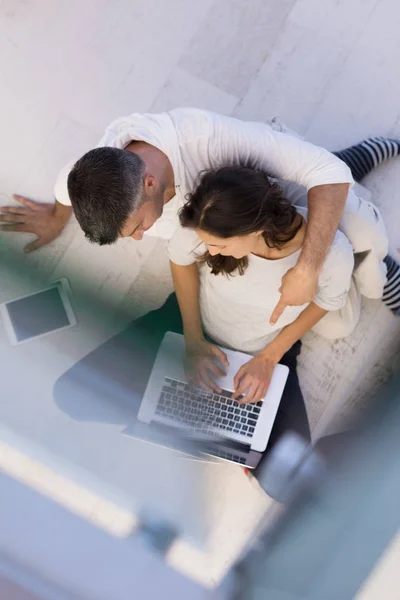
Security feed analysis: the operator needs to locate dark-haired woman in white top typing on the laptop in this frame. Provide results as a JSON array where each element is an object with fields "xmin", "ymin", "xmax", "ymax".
[{"xmin": 169, "ymin": 167, "xmax": 359, "ymax": 462}]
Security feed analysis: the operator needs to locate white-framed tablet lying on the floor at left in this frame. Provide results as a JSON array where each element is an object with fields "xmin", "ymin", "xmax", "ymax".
[{"xmin": 0, "ymin": 278, "xmax": 76, "ymax": 345}]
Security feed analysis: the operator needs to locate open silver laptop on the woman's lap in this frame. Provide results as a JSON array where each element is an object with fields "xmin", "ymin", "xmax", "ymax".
[{"xmin": 124, "ymin": 332, "xmax": 289, "ymax": 469}]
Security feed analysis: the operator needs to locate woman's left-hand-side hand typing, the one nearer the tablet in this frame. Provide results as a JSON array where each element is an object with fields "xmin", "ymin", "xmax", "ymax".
[{"xmin": 185, "ymin": 339, "xmax": 229, "ymax": 393}]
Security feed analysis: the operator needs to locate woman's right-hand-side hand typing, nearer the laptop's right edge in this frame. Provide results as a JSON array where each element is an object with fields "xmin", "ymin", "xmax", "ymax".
[{"xmin": 232, "ymin": 354, "xmax": 276, "ymax": 404}]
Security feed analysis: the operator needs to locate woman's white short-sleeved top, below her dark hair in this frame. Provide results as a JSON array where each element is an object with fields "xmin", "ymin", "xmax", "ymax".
[{"xmin": 168, "ymin": 208, "xmax": 354, "ymax": 354}]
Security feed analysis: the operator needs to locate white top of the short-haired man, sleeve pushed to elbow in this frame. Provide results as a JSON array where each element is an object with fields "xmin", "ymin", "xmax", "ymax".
[{"xmin": 55, "ymin": 108, "xmax": 353, "ymax": 239}]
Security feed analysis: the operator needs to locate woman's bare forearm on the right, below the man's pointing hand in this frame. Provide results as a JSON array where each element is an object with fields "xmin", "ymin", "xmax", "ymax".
[{"xmin": 260, "ymin": 302, "xmax": 328, "ymax": 363}]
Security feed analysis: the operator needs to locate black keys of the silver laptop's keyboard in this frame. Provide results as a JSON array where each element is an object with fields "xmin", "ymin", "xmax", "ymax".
[{"xmin": 156, "ymin": 377, "xmax": 262, "ymax": 438}]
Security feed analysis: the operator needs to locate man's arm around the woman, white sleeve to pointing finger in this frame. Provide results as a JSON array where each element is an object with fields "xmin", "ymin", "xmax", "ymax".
[{"xmin": 209, "ymin": 113, "xmax": 353, "ymax": 322}]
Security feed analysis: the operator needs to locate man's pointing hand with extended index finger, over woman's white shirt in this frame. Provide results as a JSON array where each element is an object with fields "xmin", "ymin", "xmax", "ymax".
[{"xmin": 269, "ymin": 265, "xmax": 319, "ymax": 325}]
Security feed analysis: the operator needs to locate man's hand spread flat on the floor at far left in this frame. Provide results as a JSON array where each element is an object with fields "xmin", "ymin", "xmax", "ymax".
[{"xmin": 0, "ymin": 194, "xmax": 72, "ymax": 252}]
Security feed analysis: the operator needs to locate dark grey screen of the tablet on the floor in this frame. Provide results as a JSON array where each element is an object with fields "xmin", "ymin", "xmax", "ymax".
[{"xmin": 7, "ymin": 286, "xmax": 70, "ymax": 342}]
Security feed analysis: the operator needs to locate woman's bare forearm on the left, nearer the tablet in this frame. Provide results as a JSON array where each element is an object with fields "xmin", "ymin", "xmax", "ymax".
[{"xmin": 170, "ymin": 261, "xmax": 203, "ymax": 341}]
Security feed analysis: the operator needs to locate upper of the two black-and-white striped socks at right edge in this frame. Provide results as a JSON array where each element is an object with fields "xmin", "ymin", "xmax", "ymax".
[{"xmin": 332, "ymin": 137, "xmax": 400, "ymax": 182}]
